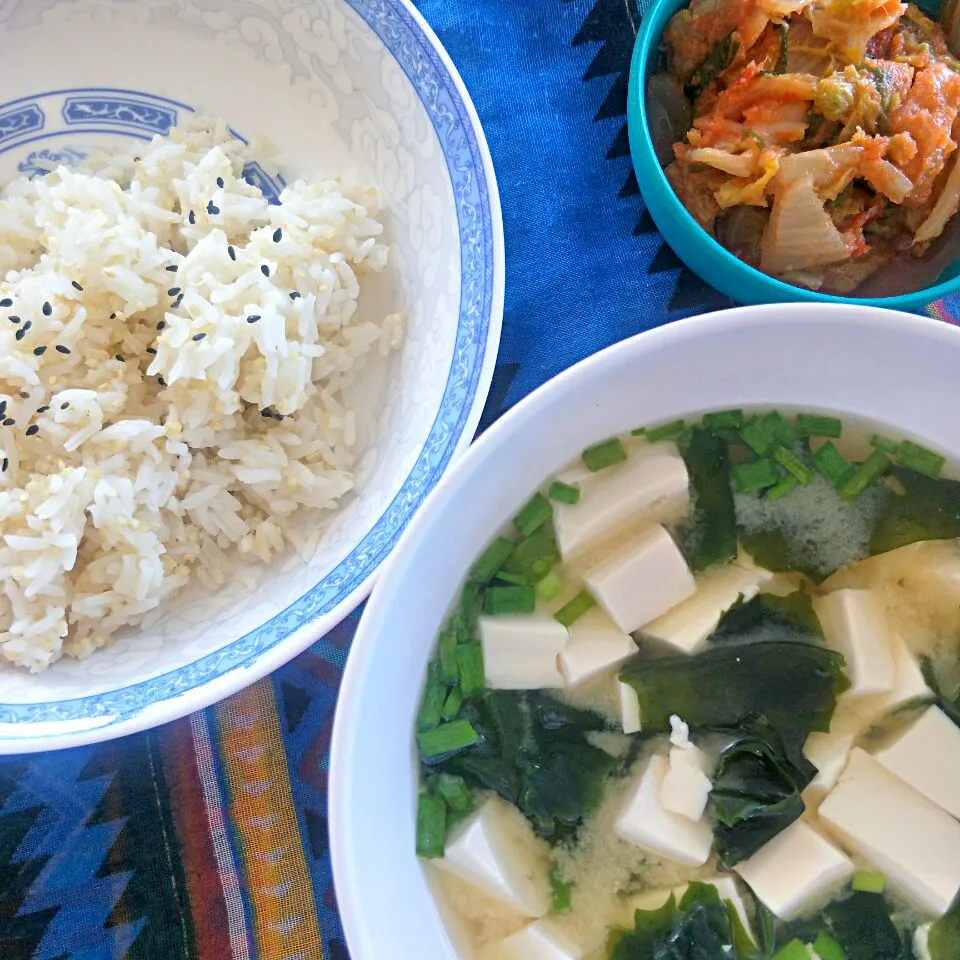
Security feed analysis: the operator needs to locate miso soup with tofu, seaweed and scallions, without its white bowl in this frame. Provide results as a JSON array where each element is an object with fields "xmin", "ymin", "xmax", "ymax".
[{"xmin": 416, "ymin": 411, "xmax": 960, "ymax": 960}]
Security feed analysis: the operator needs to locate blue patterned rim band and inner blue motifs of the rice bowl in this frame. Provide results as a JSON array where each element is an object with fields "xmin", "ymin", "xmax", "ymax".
[{"xmin": 0, "ymin": 0, "xmax": 497, "ymax": 724}]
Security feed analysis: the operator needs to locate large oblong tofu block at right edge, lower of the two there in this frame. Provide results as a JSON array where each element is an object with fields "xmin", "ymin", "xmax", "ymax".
[{"xmin": 820, "ymin": 747, "xmax": 960, "ymax": 916}]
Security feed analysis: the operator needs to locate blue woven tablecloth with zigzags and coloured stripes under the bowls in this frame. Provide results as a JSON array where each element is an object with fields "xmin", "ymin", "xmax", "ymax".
[{"xmin": 0, "ymin": 0, "xmax": 960, "ymax": 960}]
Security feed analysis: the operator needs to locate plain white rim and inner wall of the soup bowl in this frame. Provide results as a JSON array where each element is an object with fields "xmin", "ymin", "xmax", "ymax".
[{"xmin": 331, "ymin": 304, "xmax": 960, "ymax": 960}]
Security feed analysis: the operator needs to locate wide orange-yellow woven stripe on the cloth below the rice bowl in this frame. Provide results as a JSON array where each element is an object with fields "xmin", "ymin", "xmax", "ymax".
[{"xmin": 216, "ymin": 680, "xmax": 323, "ymax": 960}]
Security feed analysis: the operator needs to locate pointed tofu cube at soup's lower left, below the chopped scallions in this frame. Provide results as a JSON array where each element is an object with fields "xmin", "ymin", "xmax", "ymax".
[{"xmin": 432, "ymin": 797, "xmax": 550, "ymax": 917}]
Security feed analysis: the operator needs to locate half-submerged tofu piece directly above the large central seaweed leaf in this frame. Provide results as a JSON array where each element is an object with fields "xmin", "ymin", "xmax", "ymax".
[{"xmin": 643, "ymin": 563, "xmax": 773, "ymax": 654}]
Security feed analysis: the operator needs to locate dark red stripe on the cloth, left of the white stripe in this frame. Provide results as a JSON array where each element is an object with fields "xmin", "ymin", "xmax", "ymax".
[{"xmin": 161, "ymin": 718, "xmax": 233, "ymax": 960}]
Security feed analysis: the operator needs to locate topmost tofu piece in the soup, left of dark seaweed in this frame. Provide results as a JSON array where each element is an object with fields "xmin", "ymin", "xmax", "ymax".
[{"xmin": 553, "ymin": 443, "xmax": 690, "ymax": 560}]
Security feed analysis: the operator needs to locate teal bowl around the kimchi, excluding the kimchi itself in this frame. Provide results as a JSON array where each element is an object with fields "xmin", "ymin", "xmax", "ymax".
[{"xmin": 627, "ymin": 0, "xmax": 960, "ymax": 310}]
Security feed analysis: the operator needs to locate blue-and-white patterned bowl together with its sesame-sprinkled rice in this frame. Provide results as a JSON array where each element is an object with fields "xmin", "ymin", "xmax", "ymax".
[{"xmin": 0, "ymin": 0, "xmax": 503, "ymax": 753}]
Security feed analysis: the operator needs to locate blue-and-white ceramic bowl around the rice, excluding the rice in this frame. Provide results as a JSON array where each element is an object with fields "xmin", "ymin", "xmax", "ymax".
[{"xmin": 0, "ymin": 0, "xmax": 503, "ymax": 752}]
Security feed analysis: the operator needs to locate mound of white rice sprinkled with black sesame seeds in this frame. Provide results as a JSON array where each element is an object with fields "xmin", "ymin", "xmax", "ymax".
[{"xmin": 0, "ymin": 120, "xmax": 402, "ymax": 671}]
